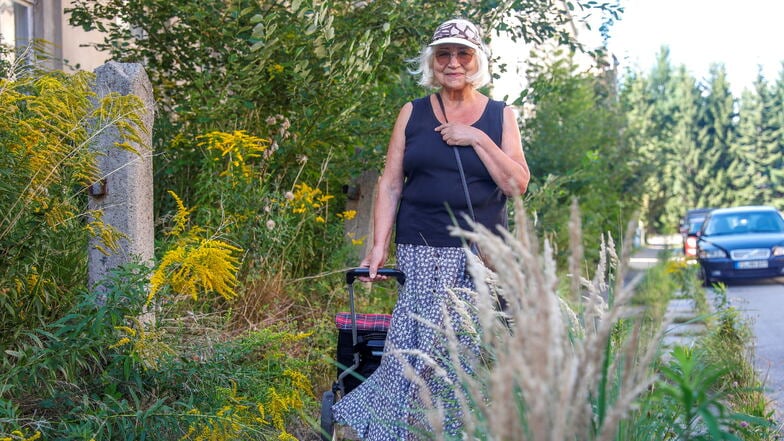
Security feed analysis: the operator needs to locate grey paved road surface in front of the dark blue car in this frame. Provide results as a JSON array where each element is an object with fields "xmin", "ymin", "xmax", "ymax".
[{"xmin": 727, "ymin": 278, "xmax": 784, "ymax": 421}]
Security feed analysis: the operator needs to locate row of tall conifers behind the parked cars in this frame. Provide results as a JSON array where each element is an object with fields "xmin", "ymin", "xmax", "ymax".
[{"xmin": 620, "ymin": 47, "xmax": 784, "ymax": 233}]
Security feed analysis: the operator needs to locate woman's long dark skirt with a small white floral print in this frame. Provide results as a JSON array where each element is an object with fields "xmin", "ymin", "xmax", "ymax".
[{"xmin": 333, "ymin": 244, "xmax": 479, "ymax": 441}]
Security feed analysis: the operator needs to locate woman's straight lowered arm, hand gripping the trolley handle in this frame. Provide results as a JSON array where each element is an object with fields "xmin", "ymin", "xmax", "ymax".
[{"xmin": 360, "ymin": 103, "xmax": 413, "ymax": 281}]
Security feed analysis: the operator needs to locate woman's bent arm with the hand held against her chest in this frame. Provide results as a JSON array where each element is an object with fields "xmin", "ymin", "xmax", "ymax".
[{"xmin": 436, "ymin": 106, "xmax": 531, "ymax": 196}]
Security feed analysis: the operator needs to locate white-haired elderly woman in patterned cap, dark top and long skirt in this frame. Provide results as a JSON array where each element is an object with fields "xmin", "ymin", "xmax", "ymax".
[{"xmin": 333, "ymin": 19, "xmax": 530, "ymax": 441}]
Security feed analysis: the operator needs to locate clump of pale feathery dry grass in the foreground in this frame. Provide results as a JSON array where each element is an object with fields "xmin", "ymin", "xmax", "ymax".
[{"xmin": 402, "ymin": 201, "xmax": 659, "ymax": 440}]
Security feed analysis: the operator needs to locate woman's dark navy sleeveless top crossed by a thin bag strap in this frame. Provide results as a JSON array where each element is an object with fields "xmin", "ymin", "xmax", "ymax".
[{"xmin": 395, "ymin": 96, "xmax": 506, "ymax": 247}]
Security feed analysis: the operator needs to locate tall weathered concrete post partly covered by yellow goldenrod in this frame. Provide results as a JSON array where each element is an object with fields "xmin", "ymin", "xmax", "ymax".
[{"xmin": 87, "ymin": 61, "xmax": 155, "ymax": 294}]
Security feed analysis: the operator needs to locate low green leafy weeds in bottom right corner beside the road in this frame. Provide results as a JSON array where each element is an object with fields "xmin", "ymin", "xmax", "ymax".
[{"xmin": 618, "ymin": 263, "xmax": 775, "ymax": 441}]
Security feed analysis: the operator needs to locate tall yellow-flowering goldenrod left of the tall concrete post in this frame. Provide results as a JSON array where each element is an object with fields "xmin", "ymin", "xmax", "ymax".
[{"xmin": 0, "ymin": 72, "xmax": 143, "ymax": 349}]
